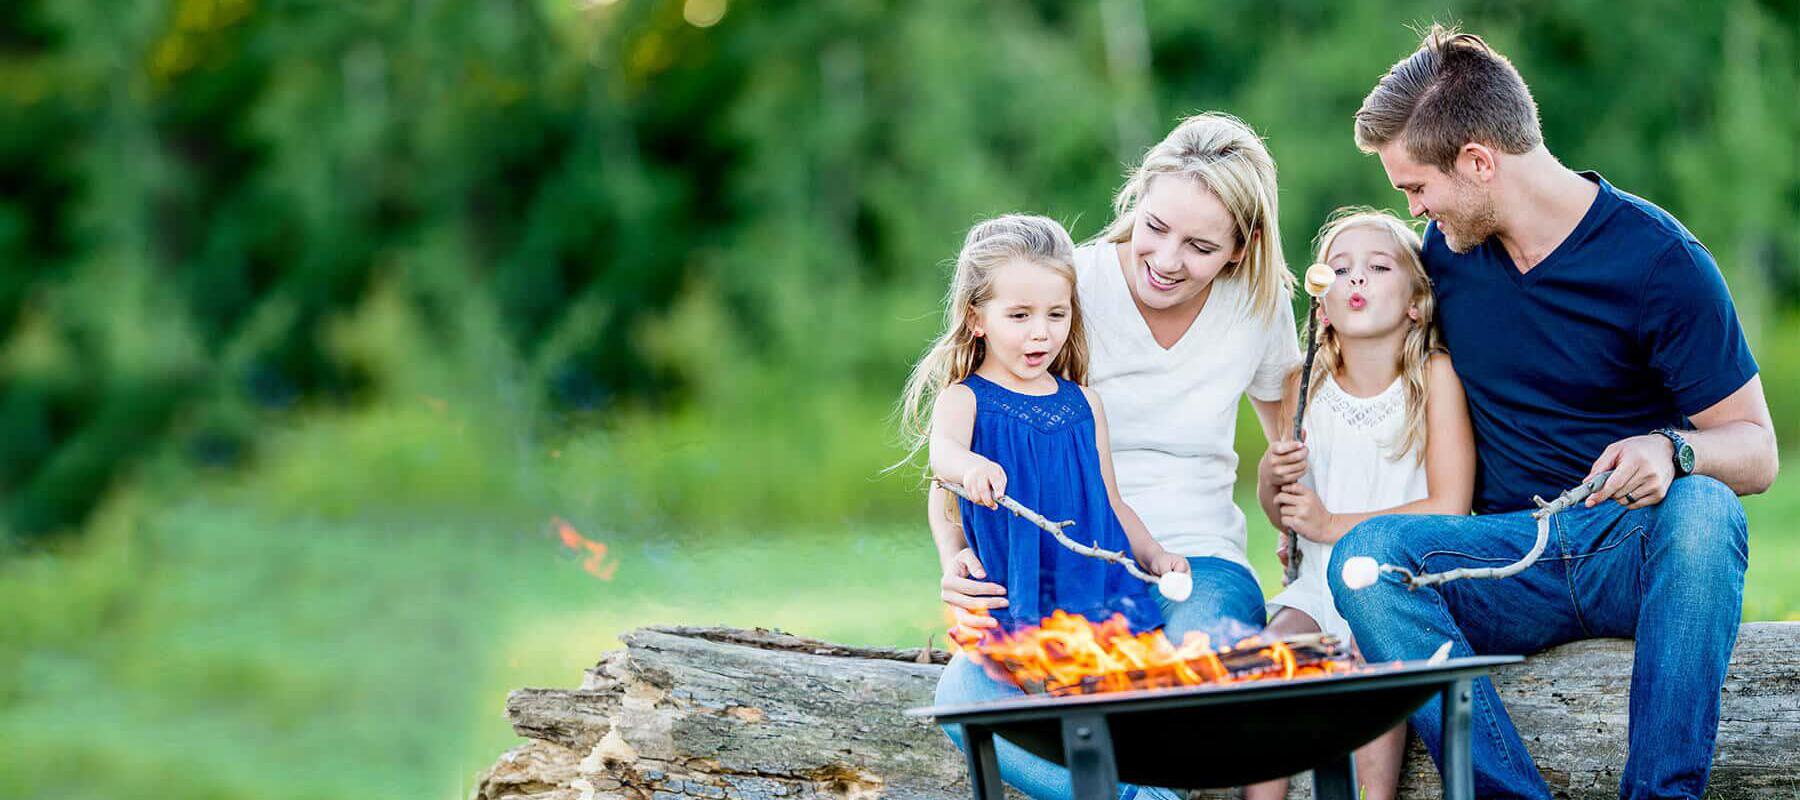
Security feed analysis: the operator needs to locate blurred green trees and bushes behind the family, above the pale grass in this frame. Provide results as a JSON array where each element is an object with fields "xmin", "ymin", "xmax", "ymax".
[{"xmin": 0, "ymin": 0, "xmax": 1800, "ymax": 533}]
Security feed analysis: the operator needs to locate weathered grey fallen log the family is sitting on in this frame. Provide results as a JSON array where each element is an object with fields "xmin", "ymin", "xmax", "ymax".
[{"xmin": 473, "ymin": 622, "xmax": 1800, "ymax": 800}]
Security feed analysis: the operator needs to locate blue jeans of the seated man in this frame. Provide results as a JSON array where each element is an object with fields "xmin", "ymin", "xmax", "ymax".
[{"xmin": 1327, "ymin": 476, "xmax": 1750, "ymax": 798}]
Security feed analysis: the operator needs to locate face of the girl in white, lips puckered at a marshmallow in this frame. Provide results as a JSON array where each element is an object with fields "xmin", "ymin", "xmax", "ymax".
[{"xmin": 1323, "ymin": 225, "xmax": 1418, "ymax": 339}]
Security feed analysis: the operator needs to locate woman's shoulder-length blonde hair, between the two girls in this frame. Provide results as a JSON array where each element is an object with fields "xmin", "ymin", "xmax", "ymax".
[{"xmin": 1098, "ymin": 112, "xmax": 1294, "ymax": 319}]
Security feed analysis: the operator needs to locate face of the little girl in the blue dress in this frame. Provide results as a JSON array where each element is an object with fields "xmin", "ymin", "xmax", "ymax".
[{"xmin": 970, "ymin": 259, "xmax": 1075, "ymax": 386}]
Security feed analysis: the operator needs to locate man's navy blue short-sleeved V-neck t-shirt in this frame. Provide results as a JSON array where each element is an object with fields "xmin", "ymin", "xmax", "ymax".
[{"xmin": 1424, "ymin": 173, "xmax": 1757, "ymax": 514}]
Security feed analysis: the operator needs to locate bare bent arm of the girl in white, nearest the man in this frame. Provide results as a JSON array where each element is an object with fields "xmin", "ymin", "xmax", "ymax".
[{"xmin": 1278, "ymin": 353, "xmax": 1474, "ymax": 544}]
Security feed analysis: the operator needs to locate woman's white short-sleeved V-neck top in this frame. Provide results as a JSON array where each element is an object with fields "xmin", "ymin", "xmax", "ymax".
[{"xmin": 1073, "ymin": 241, "xmax": 1300, "ymax": 573}]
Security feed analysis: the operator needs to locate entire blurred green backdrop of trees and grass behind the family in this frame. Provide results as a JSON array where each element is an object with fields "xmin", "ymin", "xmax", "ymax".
[{"xmin": 0, "ymin": 0, "xmax": 1800, "ymax": 798}]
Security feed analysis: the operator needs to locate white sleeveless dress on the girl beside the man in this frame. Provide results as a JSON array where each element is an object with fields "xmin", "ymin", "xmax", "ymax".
[{"xmin": 1269, "ymin": 375, "xmax": 1427, "ymax": 641}]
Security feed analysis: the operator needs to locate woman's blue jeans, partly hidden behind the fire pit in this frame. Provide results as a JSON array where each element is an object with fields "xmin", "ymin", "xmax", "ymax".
[{"xmin": 936, "ymin": 559, "xmax": 1264, "ymax": 800}]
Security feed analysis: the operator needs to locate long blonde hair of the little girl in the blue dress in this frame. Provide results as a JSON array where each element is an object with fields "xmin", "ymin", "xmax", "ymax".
[{"xmin": 889, "ymin": 214, "xmax": 1087, "ymax": 468}]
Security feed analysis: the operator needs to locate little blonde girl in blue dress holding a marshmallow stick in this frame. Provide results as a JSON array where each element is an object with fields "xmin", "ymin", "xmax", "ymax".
[{"xmin": 902, "ymin": 214, "xmax": 1188, "ymax": 798}]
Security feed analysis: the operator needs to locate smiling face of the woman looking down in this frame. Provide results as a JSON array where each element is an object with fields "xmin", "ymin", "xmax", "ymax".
[{"xmin": 1127, "ymin": 175, "xmax": 1244, "ymax": 310}]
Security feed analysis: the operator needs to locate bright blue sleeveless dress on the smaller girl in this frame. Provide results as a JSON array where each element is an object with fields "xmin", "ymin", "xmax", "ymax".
[{"xmin": 958, "ymin": 375, "xmax": 1163, "ymax": 631}]
